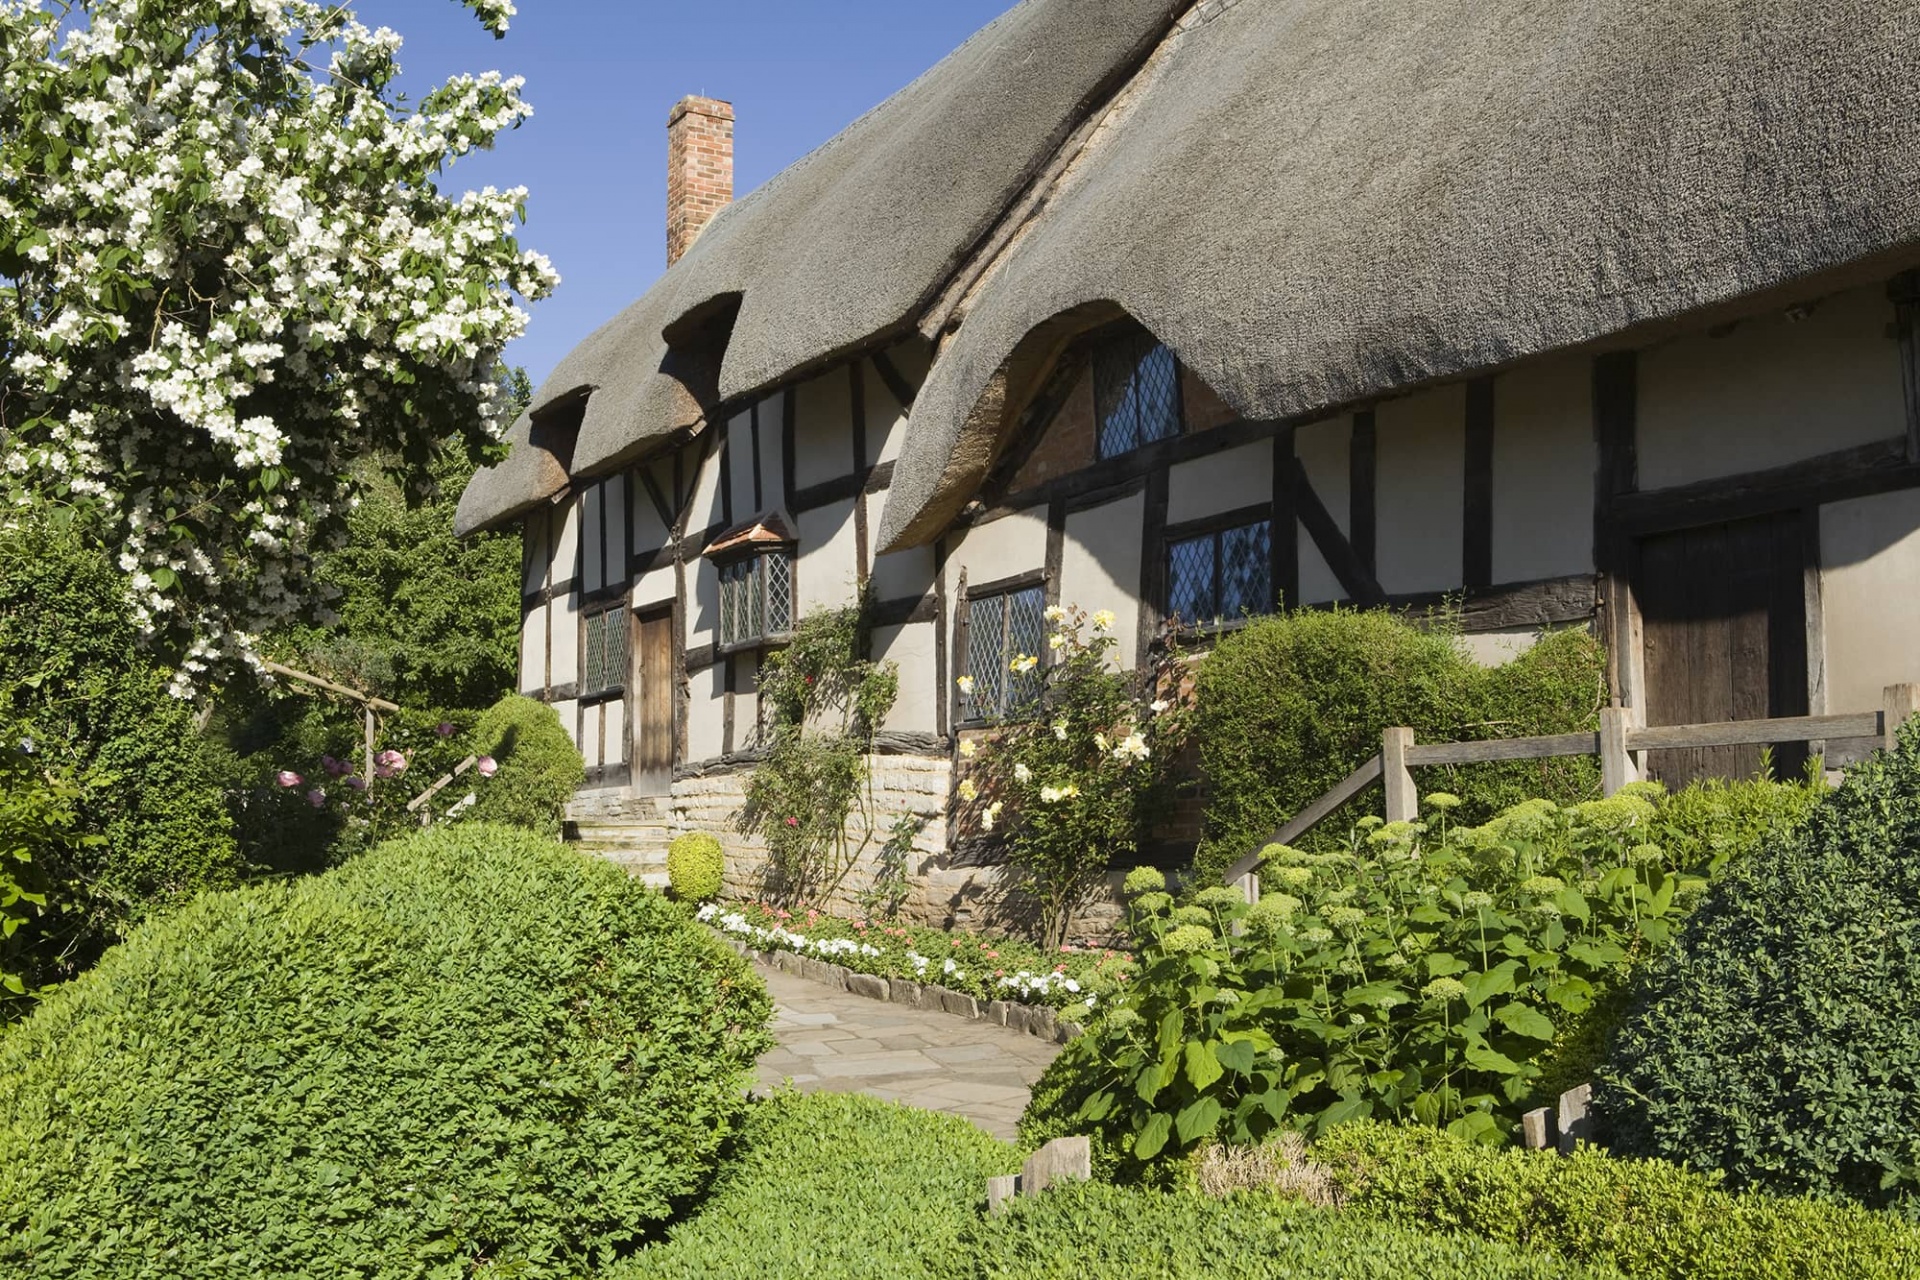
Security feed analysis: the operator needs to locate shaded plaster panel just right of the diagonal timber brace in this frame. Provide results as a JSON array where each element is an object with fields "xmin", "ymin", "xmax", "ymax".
[{"xmin": 1373, "ymin": 384, "xmax": 1467, "ymax": 595}]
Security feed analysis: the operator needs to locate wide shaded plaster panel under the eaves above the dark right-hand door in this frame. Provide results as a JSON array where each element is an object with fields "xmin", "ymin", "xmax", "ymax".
[{"xmin": 1636, "ymin": 288, "xmax": 1907, "ymax": 489}]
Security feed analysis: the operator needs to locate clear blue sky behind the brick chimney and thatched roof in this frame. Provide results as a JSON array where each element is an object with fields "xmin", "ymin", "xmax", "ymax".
[{"xmin": 355, "ymin": 0, "xmax": 1012, "ymax": 384}]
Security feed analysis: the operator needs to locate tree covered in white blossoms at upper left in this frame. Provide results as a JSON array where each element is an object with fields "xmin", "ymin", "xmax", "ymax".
[{"xmin": 0, "ymin": 0, "xmax": 557, "ymax": 695}]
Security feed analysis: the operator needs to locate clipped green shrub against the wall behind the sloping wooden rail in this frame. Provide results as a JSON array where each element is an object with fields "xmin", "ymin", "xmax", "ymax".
[{"xmin": 1192, "ymin": 608, "xmax": 1605, "ymax": 883}]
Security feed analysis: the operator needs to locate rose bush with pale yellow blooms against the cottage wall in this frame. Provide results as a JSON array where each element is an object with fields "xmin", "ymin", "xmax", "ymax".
[{"xmin": 958, "ymin": 604, "xmax": 1187, "ymax": 946}]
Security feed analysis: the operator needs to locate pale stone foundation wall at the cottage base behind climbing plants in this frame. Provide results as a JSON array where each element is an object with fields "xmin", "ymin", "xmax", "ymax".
[{"xmin": 664, "ymin": 754, "xmax": 1123, "ymax": 942}]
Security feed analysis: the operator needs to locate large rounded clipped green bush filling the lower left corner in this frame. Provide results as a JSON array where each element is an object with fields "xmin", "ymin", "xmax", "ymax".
[{"xmin": 0, "ymin": 825, "xmax": 770, "ymax": 1280}]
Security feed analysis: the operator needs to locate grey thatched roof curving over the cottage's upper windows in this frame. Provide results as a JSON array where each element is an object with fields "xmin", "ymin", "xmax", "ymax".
[{"xmin": 463, "ymin": 0, "xmax": 1920, "ymax": 547}]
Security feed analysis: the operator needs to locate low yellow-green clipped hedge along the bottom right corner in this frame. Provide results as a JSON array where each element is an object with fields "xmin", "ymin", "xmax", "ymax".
[{"xmin": 1313, "ymin": 1125, "xmax": 1920, "ymax": 1280}]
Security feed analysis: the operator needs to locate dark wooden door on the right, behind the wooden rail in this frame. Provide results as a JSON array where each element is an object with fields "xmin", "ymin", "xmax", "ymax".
[{"xmin": 1634, "ymin": 510, "xmax": 1807, "ymax": 787}]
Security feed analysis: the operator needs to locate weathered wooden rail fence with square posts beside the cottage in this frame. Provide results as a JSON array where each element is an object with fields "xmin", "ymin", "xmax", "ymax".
[{"xmin": 1227, "ymin": 685, "xmax": 1920, "ymax": 896}]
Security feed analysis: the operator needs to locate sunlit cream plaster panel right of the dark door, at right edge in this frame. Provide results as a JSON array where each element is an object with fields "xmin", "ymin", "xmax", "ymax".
[{"xmin": 1820, "ymin": 489, "xmax": 1920, "ymax": 714}]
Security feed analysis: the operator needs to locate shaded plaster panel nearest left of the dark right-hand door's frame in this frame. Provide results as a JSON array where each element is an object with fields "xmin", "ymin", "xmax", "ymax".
[{"xmin": 1494, "ymin": 357, "xmax": 1596, "ymax": 581}]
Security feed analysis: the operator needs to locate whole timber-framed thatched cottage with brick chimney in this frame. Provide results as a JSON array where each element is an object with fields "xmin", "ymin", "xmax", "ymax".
[{"xmin": 461, "ymin": 0, "xmax": 1920, "ymax": 915}]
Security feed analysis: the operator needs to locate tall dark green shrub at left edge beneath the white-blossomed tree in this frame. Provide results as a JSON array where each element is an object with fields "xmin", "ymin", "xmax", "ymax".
[{"xmin": 0, "ymin": 516, "xmax": 242, "ymax": 963}]
